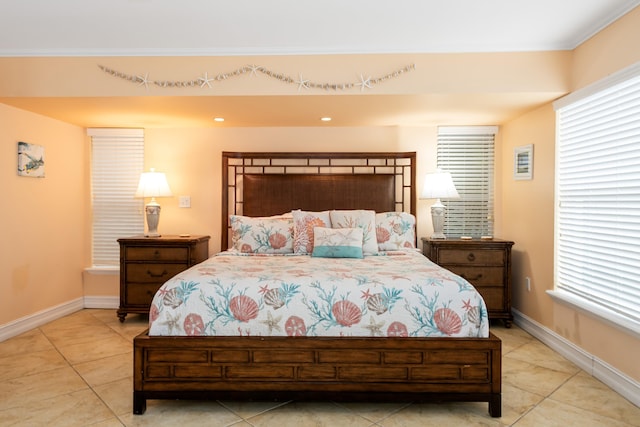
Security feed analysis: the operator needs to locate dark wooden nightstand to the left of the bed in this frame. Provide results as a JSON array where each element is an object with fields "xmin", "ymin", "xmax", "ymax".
[{"xmin": 118, "ymin": 235, "xmax": 209, "ymax": 322}]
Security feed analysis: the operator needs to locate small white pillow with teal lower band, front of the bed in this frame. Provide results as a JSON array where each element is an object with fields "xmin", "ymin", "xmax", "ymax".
[{"xmin": 311, "ymin": 227, "xmax": 363, "ymax": 258}]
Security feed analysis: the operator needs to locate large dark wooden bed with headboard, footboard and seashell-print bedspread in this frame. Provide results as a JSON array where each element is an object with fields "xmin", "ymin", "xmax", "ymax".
[{"xmin": 133, "ymin": 152, "xmax": 501, "ymax": 417}]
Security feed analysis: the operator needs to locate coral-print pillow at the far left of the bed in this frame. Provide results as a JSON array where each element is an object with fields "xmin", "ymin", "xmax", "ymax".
[{"xmin": 229, "ymin": 215, "xmax": 293, "ymax": 254}]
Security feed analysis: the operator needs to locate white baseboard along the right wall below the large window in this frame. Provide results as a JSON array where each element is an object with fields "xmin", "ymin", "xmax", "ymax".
[{"xmin": 511, "ymin": 309, "xmax": 640, "ymax": 406}]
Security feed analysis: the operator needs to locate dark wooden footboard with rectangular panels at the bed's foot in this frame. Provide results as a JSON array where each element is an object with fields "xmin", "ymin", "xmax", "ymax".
[{"xmin": 133, "ymin": 332, "xmax": 502, "ymax": 417}]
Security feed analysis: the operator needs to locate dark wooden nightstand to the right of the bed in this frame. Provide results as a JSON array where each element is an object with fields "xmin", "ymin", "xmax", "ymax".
[{"xmin": 422, "ymin": 238, "xmax": 514, "ymax": 328}]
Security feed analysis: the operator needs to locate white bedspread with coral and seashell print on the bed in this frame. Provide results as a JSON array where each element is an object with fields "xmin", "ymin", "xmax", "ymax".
[{"xmin": 149, "ymin": 251, "xmax": 489, "ymax": 337}]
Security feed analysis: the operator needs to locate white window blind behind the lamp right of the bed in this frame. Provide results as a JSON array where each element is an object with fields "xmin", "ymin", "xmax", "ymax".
[{"xmin": 437, "ymin": 126, "xmax": 498, "ymax": 237}]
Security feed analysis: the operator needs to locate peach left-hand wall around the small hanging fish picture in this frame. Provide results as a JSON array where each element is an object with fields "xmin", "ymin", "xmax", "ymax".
[{"xmin": 0, "ymin": 104, "xmax": 87, "ymax": 325}]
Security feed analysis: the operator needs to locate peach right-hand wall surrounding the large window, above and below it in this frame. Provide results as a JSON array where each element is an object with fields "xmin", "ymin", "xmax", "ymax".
[{"xmin": 502, "ymin": 8, "xmax": 640, "ymax": 381}]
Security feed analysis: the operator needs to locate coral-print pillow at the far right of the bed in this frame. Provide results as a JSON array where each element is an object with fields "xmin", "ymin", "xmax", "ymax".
[{"xmin": 376, "ymin": 212, "xmax": 416, "ymax": 251}]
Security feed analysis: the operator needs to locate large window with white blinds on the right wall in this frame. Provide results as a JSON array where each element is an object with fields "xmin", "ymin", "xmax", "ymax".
[{"xmin": 552, "ymin": 64, "xmax": 640, "ymax": 333}]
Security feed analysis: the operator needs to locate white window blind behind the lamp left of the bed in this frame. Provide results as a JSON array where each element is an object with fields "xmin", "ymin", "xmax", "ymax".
[{"xmin": 87, "ymin": 129, "xmax": 144, "ymax": 267}]
